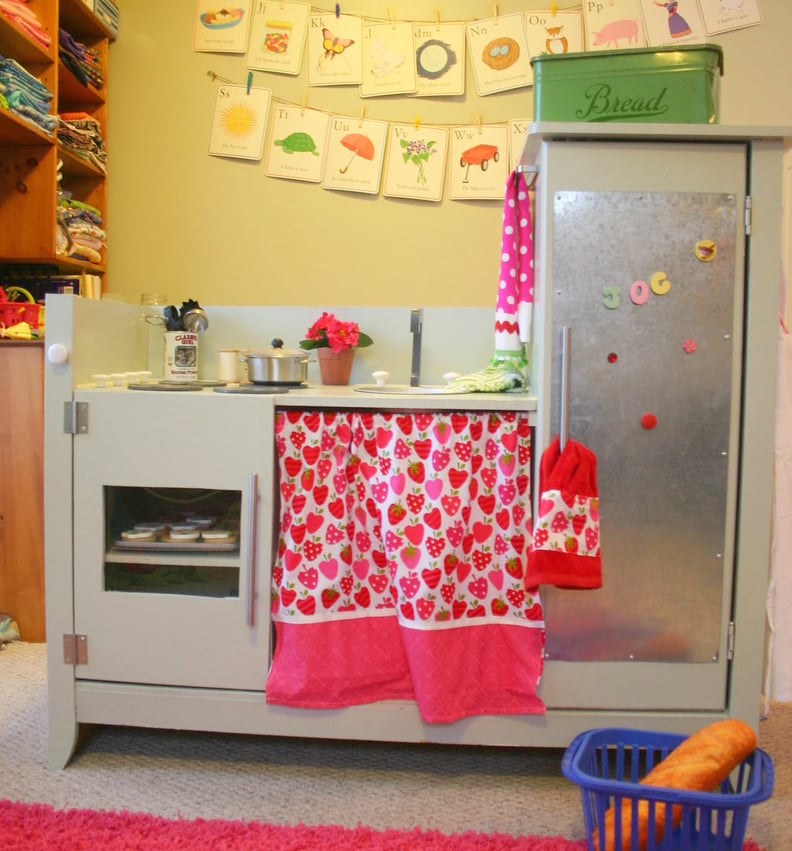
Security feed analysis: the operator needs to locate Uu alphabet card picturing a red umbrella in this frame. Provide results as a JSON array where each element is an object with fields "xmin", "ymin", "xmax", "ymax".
[{"xmin": 322, "ymin": 115, "xmax": 388, "ymax": 195}]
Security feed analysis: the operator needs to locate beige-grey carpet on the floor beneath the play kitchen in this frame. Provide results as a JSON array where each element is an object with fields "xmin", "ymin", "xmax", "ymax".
[{"xmin": 0, "ymin": 642, "xmax": 792, "ymax": 851}]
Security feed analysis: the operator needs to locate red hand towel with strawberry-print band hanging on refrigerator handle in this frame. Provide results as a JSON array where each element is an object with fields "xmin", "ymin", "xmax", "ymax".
[{"xmin": 525, "ymin": 438, "xmax": 602, "ymax": 588}]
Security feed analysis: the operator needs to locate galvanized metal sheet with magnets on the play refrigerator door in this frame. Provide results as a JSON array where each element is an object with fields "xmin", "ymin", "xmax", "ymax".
[{"xmin": 544, "ymin": 191, "xmax": 741, "ymax": 662}]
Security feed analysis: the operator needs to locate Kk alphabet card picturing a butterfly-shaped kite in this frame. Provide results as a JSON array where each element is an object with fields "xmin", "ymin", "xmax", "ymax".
[{"xmin": 308, "ymin": 14, "xmax": 363, "ymax": 86}]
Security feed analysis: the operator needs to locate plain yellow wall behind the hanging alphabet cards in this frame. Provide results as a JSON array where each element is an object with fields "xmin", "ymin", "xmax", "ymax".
[{"xmin": 107, "ymin": 0, "xmax": 792, "ymax": 307}]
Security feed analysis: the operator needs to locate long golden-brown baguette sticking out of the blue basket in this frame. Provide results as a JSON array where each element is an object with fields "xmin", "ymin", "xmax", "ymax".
[{"xmin": 593, "ymin": 718, "xmax": 756, "ymax": 851}]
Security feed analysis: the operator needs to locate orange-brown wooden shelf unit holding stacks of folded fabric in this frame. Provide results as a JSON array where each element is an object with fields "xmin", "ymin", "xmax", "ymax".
[{"xmin": 0, "ymin": 0, "xmax": 112, "ymax": 273}]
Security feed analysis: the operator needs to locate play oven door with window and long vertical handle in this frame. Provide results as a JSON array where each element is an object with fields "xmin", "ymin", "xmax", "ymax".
[{"xmin": 74, "ymin": 390, "xmax": 273, "ymax": 689}]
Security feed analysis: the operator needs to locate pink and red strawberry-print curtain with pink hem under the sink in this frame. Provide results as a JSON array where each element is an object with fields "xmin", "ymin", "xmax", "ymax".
[{"xmin": 266, "ymin": 410, "xmax": 544, "ymax": 723}]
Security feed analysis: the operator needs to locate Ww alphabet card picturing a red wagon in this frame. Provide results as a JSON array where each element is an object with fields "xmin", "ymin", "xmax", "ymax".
[{"xmin": 448, "ymin": 124, "xmax": 509, "ymax": 201}]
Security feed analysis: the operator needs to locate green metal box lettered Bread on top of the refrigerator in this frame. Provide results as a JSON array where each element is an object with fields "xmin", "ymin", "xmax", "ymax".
[{"xmin": 531, "ymin": 44, "xmax": 723, "ymax": 124}]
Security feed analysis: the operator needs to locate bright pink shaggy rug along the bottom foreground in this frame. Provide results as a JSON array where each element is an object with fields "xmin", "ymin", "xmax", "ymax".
[{"xmin": 0, "ymin": 800, "xmax": 761, "ymax": 851}]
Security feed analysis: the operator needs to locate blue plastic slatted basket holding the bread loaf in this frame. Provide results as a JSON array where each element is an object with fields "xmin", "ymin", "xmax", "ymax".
[{"xmin": 561, "ymin": 727, "xmax": 774, "ymax": 851}]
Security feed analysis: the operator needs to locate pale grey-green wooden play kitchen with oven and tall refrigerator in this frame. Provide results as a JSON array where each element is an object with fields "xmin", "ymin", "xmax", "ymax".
[{"xmin": 46, "ymin": 124, "xmax": 787, "ymax": 766}]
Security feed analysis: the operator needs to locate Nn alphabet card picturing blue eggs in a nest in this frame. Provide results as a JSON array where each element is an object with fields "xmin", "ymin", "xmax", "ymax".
[{"xmin": 467, "ymin": 13, "xmax": 533, "ymax": 95}]
